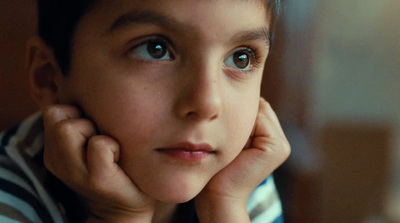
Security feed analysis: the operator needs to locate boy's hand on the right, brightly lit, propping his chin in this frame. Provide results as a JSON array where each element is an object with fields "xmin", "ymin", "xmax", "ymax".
[{"xmin": 196, "ymin": 98, "xmax": 290, "ymax": 222}]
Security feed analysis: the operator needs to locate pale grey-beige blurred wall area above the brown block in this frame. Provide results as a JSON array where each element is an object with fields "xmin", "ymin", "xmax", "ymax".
[{"xmin": 311, "ymin": 0, "xmax": 400, "ymax": 126}]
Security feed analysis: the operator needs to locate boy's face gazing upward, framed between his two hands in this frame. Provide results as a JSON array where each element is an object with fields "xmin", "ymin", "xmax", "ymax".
[{"xmin": 58, "ymin": 0, "xmax": 269, "ymax": 202}]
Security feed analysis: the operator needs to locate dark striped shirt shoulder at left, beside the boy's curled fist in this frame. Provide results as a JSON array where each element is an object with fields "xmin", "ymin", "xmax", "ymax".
[{"xmin": 0, "ymin": 114, "xmax": 63, "ymax": 222}]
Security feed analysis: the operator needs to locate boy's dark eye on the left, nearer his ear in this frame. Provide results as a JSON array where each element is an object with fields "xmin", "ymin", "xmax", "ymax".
[{"xmin": 129, "ymin": 38, "xmax": 173, "ymax": 60}]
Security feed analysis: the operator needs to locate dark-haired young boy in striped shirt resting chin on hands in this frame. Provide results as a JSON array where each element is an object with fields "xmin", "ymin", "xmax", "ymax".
[{"xmin": 0, "ymin": 0, "xmax": 290, "ymax": 223}]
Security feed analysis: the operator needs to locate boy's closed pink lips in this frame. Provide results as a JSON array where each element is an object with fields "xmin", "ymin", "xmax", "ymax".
[{"xmin": 156, "ymin": 142, "xmax": 215, "ymax": 162}]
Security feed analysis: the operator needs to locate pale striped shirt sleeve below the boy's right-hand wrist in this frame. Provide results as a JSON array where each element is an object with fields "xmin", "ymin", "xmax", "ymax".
[{"xmin": 247, "ymin": 176, "xmax": 283, "ymax": 223}]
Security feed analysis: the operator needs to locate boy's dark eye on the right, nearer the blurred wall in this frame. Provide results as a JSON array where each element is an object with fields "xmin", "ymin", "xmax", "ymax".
[{"xmin": 224, "ymin": 49, "xmax": 255, "ymax": 70}]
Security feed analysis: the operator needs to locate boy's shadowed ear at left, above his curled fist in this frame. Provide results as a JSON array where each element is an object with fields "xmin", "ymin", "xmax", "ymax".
[{"xmin": 26, "ymin": 37, "xmax": 63, "ymax": 109}]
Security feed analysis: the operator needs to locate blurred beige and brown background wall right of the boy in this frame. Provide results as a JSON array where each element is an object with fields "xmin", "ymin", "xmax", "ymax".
[{"xmin": 268, "ymin": 0, "xmax": 400, "ymax": 223}]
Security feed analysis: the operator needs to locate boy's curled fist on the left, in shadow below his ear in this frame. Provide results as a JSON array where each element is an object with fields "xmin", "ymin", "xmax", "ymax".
[{"xmin": 43, "ymin": 105, "xmax": 154, "ymax": 222}]
